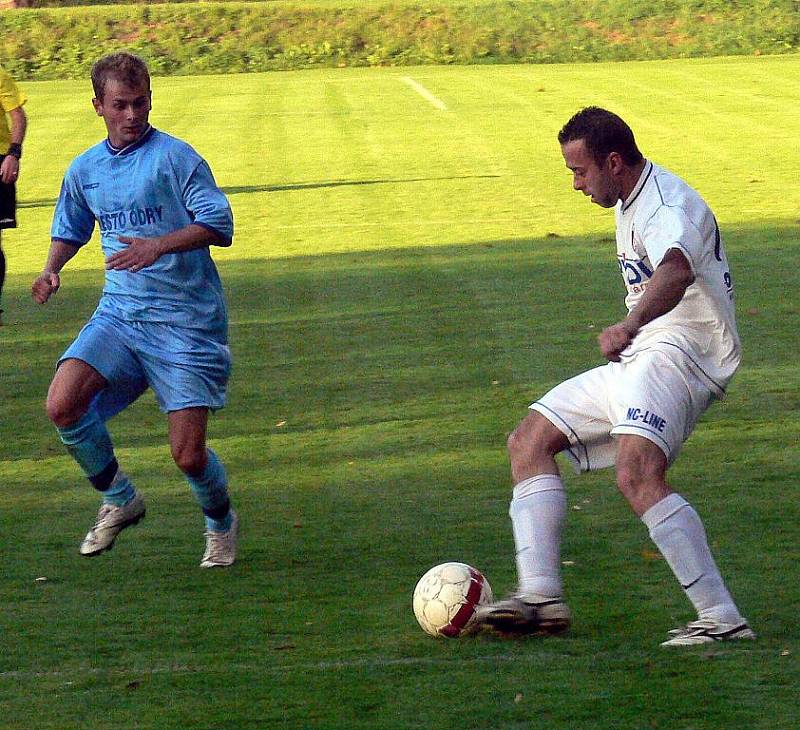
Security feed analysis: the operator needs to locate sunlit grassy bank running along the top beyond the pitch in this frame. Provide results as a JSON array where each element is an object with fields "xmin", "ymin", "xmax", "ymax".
[{"xmin": 0, "ymin": 0, "xmax": 800, "ymax": 79}]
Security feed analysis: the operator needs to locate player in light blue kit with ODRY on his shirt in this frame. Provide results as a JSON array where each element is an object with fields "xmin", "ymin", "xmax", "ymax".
[{"xmin": 32, "ymin": 52, "xmax": 238, "ymax": 568}]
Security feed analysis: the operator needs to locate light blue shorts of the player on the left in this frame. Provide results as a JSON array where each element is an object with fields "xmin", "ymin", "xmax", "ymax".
[{"xmin": 58, "ymin": 312, "xmax": 231, "ymax": 420}]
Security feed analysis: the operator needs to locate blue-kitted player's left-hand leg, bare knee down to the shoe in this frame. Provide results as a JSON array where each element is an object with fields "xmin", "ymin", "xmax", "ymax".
[{"xmin": 47, "ymin": 358, "xmax": 145, "ymax": 556}]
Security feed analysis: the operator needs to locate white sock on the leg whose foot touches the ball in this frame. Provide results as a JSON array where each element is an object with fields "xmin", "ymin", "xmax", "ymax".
[{"xmin": 508, "ymin": 474, "xmax": 567, "ymax": 599}]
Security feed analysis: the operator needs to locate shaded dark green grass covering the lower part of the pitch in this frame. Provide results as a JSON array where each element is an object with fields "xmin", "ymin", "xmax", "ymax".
[{"xmin": 0, "ymin": 226, "xmax": 800, "ymax": 730}]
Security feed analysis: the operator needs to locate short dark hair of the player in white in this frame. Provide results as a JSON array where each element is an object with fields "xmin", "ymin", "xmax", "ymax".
[{"xmin": 558, "ymin": 106, "xmax": 644, "ymax": 165}]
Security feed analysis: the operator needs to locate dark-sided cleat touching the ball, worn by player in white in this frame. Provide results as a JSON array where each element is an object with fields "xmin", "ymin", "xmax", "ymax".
[{"xmin": 475, "ymin": 594, "xmax": 572, "ymax": 636}]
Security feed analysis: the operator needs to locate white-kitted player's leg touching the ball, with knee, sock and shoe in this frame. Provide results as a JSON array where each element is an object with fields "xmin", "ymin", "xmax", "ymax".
[{"xmin": 476, "ymin": 411, "xmax": 571, "ymax": 635}]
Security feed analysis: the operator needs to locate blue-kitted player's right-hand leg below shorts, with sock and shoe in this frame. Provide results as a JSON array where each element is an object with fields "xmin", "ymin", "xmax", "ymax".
[{"xmin": 169, "ymin": 408, "xmax": 239, "ymax": 568}]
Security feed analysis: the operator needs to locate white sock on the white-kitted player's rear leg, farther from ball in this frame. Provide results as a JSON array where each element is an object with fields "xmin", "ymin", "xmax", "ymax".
[{"xmin": 642, "ymin": 493, "xmax": 743, "ymax": 624}]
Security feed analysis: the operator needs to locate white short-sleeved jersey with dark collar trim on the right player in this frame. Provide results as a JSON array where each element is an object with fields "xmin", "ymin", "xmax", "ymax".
[{"xmin": 615, "ymin": 161, "xmax": 741, "ymax": 398}]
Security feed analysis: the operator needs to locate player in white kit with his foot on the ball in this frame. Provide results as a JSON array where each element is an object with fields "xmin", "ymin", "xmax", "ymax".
[{"xmin": 478, "ymin": 107, "xmax": 755, "ymax": 646}]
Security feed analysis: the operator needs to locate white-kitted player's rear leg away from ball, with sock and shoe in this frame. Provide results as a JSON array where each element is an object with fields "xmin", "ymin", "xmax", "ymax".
[{"xmin": 617, "ymin": 435, "xmax": 755, "ymax": 646}]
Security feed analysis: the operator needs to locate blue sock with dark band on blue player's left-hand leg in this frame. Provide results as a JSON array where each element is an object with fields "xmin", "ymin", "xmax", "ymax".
[{"xmin": 56, "ymin": 408, "xmax": 134, "ymax": 505}]
